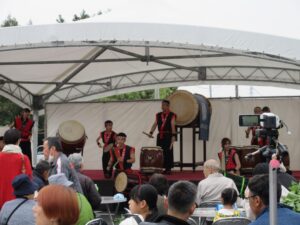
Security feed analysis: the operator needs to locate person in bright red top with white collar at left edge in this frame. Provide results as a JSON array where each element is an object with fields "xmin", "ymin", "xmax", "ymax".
[{"xmin": 0, "ymin": 129, "xmax": 32, "ymax": 209}]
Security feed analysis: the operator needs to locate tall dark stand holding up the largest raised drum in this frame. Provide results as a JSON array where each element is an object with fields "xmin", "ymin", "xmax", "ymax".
[{"xmin": 174, "ymin": 125, "xmax": 206, "ymax": 172}]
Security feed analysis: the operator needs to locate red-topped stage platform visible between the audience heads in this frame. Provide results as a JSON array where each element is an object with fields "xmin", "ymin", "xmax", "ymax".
[{"xmin": 83, "ymin": 170, "xmax": 300, "ymax": 196}]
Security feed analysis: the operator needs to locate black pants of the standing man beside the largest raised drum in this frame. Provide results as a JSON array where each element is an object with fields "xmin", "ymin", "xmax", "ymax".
[{"xmin": 156, "ymin": 134, "xmax": 174, "ymax": 170}]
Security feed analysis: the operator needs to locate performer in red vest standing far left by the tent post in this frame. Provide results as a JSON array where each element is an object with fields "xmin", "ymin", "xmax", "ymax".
[{"xmin": 11, "ymin": 108, "xmax": 34, "ymax": 165}]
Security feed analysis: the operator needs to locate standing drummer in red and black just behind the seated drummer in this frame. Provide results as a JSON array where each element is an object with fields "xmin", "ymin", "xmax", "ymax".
[{"xmin": 96, "ymin": 120, "xmax": 116, "ymax": 178}]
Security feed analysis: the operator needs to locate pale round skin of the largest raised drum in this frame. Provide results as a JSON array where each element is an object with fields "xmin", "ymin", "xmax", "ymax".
[{"xmin": 168, "ymin": 90, "xmax": 199, "ymax": 126}]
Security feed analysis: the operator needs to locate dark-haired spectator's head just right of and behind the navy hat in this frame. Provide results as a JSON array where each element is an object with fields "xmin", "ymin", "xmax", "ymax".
[{"xmin": 33, "ymin": 160, "xmax": 50, "ymax": 190}]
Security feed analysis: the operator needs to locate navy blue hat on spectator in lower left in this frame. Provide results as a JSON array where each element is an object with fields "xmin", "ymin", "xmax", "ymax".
[{"xmin": 12, "ymin": 174, "xmax": 38, "ymax": 196}]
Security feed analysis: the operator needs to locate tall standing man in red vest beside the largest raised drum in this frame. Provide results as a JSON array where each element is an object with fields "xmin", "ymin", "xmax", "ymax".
[{"xmin": 150, "ymin": 100, "xmax": 176, "ymax": 174}]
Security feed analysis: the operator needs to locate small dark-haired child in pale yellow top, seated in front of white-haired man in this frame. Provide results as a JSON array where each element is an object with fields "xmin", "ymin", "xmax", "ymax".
[{"xmin": 214, "ymin": 188, "xmax": 240, "ymax": 222}]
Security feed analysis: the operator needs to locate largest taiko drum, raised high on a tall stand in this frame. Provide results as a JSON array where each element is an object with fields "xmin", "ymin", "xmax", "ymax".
[{"xmin": 168, "ymin": 90, "xmax": 212, "ymax": 126}]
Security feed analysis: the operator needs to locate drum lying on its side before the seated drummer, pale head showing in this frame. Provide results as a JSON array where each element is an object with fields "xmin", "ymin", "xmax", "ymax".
[{"xmin": 115, "ymin": 171, "xmax": 147, "ymax": 196}]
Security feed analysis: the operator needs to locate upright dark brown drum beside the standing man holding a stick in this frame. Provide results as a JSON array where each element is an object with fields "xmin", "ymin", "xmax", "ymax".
[{"xmin": 140, "ymin": 146, "xmax": 164, "ymax": 174}]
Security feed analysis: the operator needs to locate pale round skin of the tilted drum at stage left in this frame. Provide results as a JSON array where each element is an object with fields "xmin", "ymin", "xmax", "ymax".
[{"xmin": 58, "ymin": 120, "xmax": 85, "ymax": 143}]
